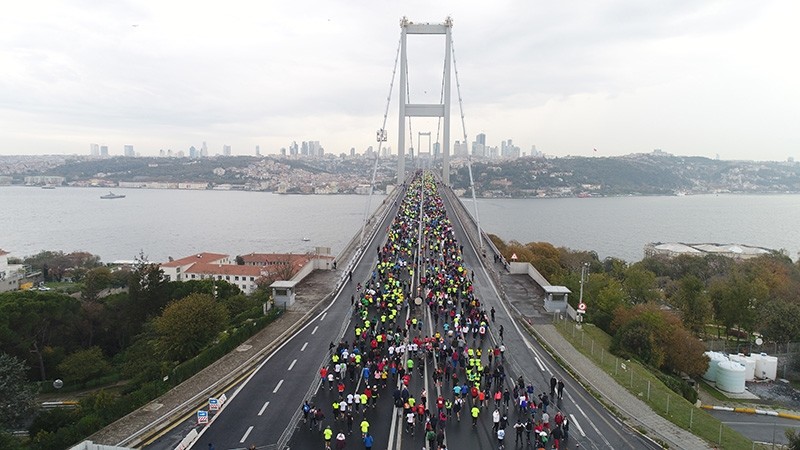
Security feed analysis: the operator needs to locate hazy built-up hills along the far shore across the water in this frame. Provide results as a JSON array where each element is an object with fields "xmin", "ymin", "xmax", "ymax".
[{"xmin": 0, "ymin": 151, "xmax": 800, "ymax": 198}]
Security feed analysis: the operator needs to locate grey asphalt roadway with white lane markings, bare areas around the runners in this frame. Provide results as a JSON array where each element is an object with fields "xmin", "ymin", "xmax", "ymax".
[{"xmin": 159, "ymin": 179, "xmax": 659, "ymax": 450}]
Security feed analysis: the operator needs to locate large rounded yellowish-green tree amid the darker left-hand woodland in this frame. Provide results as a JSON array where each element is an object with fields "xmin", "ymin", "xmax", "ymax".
[{"xmin": 155, "ymin": 294, "xmax": 228, "ymax": 361}]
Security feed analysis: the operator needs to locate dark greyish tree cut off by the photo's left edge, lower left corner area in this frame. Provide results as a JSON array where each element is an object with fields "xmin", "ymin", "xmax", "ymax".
[{"xmin": 0, "ymin": 353, "xmax": 36, "ymax": 430}]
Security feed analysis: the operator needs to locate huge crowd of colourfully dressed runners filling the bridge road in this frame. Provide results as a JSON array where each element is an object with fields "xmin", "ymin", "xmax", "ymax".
[{"xmin": 302, "ymin": 173, "xmax": 569, "ymax": 450}]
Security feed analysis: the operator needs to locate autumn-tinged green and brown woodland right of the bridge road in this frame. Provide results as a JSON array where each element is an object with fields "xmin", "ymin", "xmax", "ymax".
[{"xmin": 491, "ymin": 236, "xmax": 800, "ymax": 377}]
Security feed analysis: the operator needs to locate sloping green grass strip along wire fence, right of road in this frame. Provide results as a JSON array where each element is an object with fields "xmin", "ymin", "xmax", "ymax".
[{"xmin": 555, "ymin": 319, "xmax": 784, "ymax": 450}]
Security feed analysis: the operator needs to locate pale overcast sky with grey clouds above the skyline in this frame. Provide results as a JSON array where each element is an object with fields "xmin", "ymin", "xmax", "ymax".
[{"xmin": 0, "ymin": 0, "xmax": 800, "ymax": 160}]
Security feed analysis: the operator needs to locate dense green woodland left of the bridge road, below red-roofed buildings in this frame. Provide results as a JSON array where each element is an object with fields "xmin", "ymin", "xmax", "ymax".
[{"xmin": 0, "ymin": 252, "xmax": 280, "ymax": 450}]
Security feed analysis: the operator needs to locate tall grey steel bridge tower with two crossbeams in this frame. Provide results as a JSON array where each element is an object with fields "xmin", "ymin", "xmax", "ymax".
[{"xmin": 397, "ymin": 17, "xmax": 453, "ymax": 185}]
